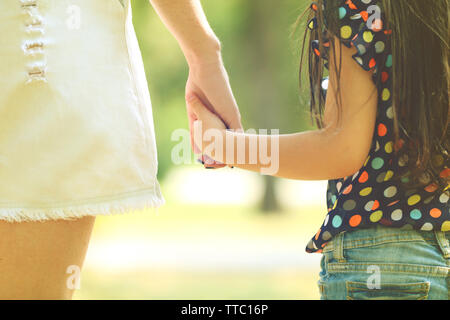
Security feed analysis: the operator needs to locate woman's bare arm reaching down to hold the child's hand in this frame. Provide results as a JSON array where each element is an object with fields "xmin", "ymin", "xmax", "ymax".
[{"xmin": 150, "ymin": 0, "xmax": 242, "ymax": 167}]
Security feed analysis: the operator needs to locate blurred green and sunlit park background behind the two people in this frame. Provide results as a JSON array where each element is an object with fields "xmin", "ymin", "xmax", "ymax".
[{"xmin": 74, "ymin": 0, "xmax": 326, "ymax": 299}]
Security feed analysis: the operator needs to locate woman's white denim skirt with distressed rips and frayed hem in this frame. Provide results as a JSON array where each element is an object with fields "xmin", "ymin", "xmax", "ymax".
[{"xmin": 0, "ymin": 0, "xmax": 164, "ymax": 222}]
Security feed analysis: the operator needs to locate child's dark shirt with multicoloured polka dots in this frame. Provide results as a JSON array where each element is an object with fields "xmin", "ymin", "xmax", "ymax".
[{"xmin": 306, "ymin": 0, "xmax": 450, "ymax": 252}]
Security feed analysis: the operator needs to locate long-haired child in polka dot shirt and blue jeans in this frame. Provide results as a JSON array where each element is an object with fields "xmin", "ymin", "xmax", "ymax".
[{"xmin": 187, "ymin": 0, "xmax": 450, "ymax": 299}]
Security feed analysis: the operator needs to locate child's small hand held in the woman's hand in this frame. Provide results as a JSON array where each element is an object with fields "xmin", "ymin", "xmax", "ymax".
[{"xmin": 186, "ymin": 94, "xmax": 227, "ymax": 161}]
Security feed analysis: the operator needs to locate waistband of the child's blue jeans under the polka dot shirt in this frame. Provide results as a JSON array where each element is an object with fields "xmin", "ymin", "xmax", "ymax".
[{"xmin": 323, "ymin": 226, "xmax": 450, "ymax": 262}]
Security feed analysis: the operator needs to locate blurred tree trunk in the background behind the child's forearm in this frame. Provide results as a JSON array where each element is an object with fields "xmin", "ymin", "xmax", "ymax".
[{"xmin": 219, "ymin": 0, "xmax": 312, "ymax": 212}]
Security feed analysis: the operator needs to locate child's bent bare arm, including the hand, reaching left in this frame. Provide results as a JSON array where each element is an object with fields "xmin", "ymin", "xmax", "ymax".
[{"xmin": 188, "ymin": 39, "xmax": 378, "ymax": 180}]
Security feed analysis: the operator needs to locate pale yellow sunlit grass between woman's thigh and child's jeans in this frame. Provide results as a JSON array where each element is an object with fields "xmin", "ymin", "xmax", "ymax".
[{"xmin": 75, "ymin": 201, "xmax": 322, "ymax": 299}]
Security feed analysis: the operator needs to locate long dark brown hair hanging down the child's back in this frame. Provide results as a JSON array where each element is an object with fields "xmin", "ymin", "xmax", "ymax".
[{"xmin": 297, "ymin": 0, "xmax": 450, "ymax": 191}]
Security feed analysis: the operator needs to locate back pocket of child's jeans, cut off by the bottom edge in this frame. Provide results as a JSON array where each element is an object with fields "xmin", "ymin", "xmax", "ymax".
[{"xmin": 346, "ymin": 281, "xmax": 430, "ymax": 300}]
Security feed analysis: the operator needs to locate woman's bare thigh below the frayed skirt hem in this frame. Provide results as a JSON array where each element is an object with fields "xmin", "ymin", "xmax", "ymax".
[{"xmin": 0, "ymin": 216, "xmax": 95, "ymax": 299}]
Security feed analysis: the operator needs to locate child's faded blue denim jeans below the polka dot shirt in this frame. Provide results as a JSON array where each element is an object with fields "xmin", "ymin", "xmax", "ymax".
[{"xmin": 318, "ymin": 226, "xmax": 450, "ymax": 300}]
